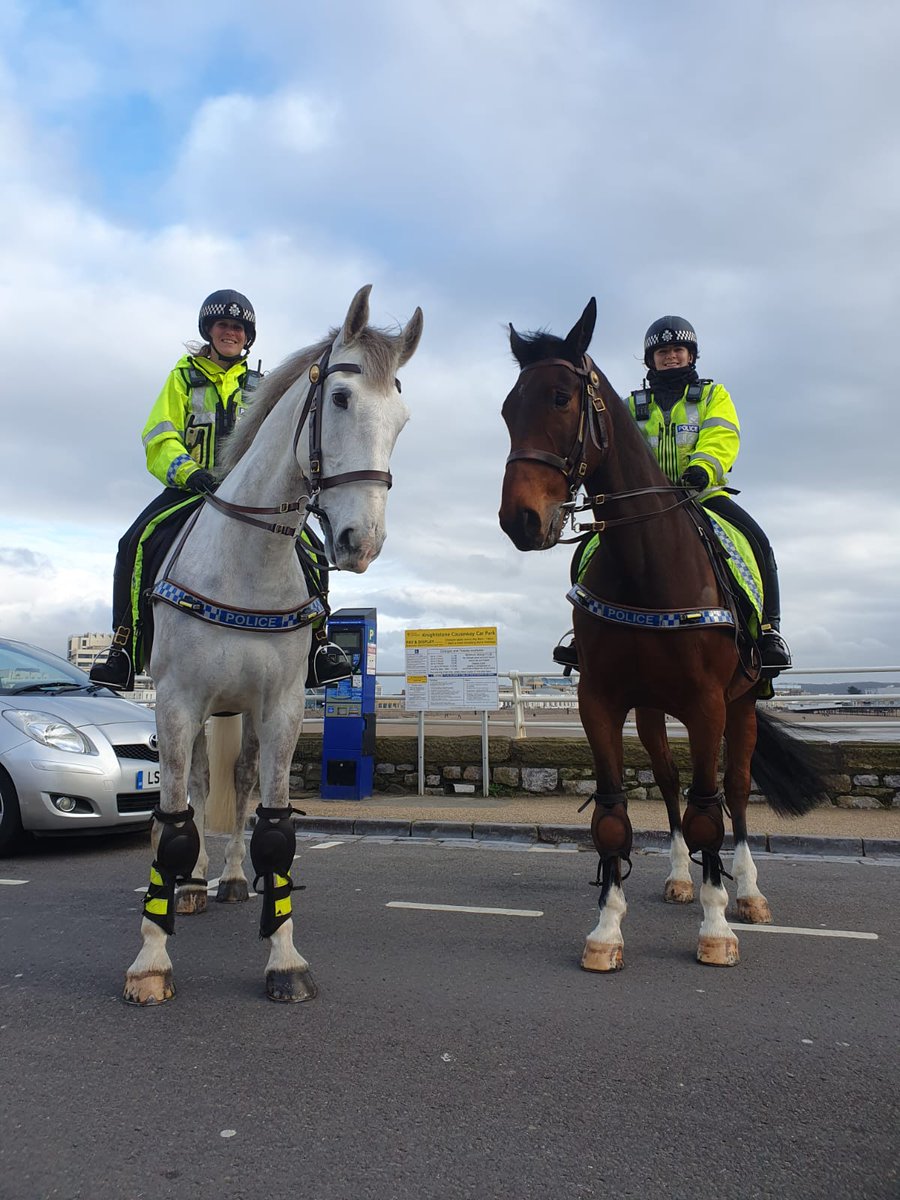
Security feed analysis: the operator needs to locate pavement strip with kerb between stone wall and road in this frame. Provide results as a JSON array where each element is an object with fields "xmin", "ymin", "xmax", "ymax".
[{"xmin": 292, "ymin": 792, "xmax": 900, "ymax": 858}]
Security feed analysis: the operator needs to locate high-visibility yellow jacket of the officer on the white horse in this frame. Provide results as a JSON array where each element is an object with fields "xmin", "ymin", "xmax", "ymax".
[{"xmin": 142, "ymin": 354, "xmax": 259, "ymax": 487}]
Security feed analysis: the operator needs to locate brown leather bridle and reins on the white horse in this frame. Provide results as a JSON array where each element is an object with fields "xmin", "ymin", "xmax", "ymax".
[{"xmin": 204, "ymin": 342, "xmax": 400, "ymax": 556}]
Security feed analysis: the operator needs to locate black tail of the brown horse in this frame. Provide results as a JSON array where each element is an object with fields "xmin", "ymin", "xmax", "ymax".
[{"xmin": 750, "ymin": 708, "xmax": 829, "ymax": 817}]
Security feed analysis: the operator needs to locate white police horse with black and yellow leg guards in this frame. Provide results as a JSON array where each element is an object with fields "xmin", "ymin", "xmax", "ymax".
[{"xmin": 125, "ymin": 287, "xmax": 422, "ymax": 1004}]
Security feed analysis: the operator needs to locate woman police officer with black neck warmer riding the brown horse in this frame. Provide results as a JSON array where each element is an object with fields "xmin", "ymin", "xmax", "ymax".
[{"xmin": 553, "ymin": 316, "xmax": 791, "ymax": 676}]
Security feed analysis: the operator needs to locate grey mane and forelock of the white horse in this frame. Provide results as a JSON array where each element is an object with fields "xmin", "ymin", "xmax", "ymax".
[{"xmin": 216, "ymin": 325, "xmax": 402, "ymax": 478}]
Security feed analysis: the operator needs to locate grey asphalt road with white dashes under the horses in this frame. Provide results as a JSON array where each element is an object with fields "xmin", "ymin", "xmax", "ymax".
[{"xmin": 0, "ymin": 836, "xmax": 900, "ymax": 1200}]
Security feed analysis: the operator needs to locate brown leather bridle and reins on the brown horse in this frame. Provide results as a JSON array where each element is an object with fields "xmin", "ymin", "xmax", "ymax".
[{"xmin": 506, "ymin": 354, "xmax": 694, "ymax": 545}]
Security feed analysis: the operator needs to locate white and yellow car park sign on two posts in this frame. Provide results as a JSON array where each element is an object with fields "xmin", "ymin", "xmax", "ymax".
[{"xmin": 406, "ymin": 625, "xmax": 500, "ymax": 796}]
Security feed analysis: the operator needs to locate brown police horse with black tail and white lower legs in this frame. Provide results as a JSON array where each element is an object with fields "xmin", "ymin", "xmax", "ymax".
[{"xmin": 499, "ymin": 299, "xmax": 824, "ymax": 971}]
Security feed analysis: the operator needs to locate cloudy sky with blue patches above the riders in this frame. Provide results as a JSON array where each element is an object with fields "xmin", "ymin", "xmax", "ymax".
[{"xmin": 0, "ymin": 0, "xmax": 900, "ymax": 671}]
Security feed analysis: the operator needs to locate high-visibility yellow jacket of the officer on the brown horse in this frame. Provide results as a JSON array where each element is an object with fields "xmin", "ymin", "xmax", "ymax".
[{"xmin": 628, "ymin": 379, "xmax": 740, "ymax": 494}]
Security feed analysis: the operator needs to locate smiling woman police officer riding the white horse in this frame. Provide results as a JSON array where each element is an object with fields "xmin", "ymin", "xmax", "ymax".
[{"xmin": 90, "ymin": 289, "xmax": 349, "ymax": 691}]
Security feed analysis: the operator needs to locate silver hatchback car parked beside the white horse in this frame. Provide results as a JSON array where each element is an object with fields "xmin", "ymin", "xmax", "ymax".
[{"xmin": 0, "ymin": 638, "xmax": 160, "ymax": 854}]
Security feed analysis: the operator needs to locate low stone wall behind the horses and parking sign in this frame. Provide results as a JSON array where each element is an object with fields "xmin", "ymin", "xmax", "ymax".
[{"xmin": 290, "ymin": 734, "xmax": 900, "ymax": 809}]
